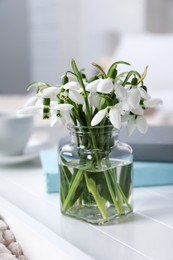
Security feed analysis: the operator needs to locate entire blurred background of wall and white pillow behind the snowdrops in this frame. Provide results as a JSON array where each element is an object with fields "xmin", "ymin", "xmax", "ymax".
[{"xmin": 0, "ymin": 0, "xmax": 173, "ymax": 123}]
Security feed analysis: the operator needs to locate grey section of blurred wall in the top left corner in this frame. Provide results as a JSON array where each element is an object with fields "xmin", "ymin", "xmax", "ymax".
[{"xmin": 0, "ymin": 0, "xmax": 30, "ymax": 94}]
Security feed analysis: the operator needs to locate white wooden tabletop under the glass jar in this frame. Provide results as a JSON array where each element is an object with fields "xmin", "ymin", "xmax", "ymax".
[{"xmin": 0, "ymin": 156, "xmax": 173, "ymax": 260}]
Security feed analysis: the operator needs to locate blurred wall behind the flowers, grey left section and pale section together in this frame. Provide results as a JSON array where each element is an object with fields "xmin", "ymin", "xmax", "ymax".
[{"xmin": 0, "ymin": 0, "xmax": 145, "ymax": 94}]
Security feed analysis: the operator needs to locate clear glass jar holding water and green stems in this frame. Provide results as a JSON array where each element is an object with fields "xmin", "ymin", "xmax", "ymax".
[{"xmin": 59, "ymin": 125, "xmax": 133, "ymax": 224}]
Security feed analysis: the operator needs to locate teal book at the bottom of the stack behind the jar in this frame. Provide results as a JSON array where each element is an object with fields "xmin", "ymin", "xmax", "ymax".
[{"xmin": 40, "ymin": 149, "xmax": 173, "ymax": 193}]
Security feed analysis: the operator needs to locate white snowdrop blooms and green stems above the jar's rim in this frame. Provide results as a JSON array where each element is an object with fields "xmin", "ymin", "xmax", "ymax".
[{"xmin": 22, "ymin": 59, "xmax": 162, "ymax": 135}]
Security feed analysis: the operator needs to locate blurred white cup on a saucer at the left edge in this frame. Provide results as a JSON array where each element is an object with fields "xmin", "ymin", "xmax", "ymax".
[{"xmin": 0, "ymin": 112, "xmax": 33, "ymax": 157}]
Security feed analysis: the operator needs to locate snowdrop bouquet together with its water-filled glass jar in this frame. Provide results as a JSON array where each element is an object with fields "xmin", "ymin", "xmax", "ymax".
[{"xmin": 22, "ymin": 59, "xmax": 161, "ymax": 224}]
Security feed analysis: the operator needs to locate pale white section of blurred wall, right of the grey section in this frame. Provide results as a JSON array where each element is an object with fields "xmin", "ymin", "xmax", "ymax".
[{"xmin": 28, "ymin": 0, "xmax": 145, "ymax": 84}]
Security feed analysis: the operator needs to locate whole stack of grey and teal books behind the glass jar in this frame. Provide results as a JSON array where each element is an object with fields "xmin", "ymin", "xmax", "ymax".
[{"xmin": 40, "ymin": 126, "xmax": 173, "ymax": 193}]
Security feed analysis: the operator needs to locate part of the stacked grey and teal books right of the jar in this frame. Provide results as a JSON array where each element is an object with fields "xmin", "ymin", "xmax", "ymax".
[{"xmin": 120, "ymin": 126, "xmax": 173, "ymax": 187}]
